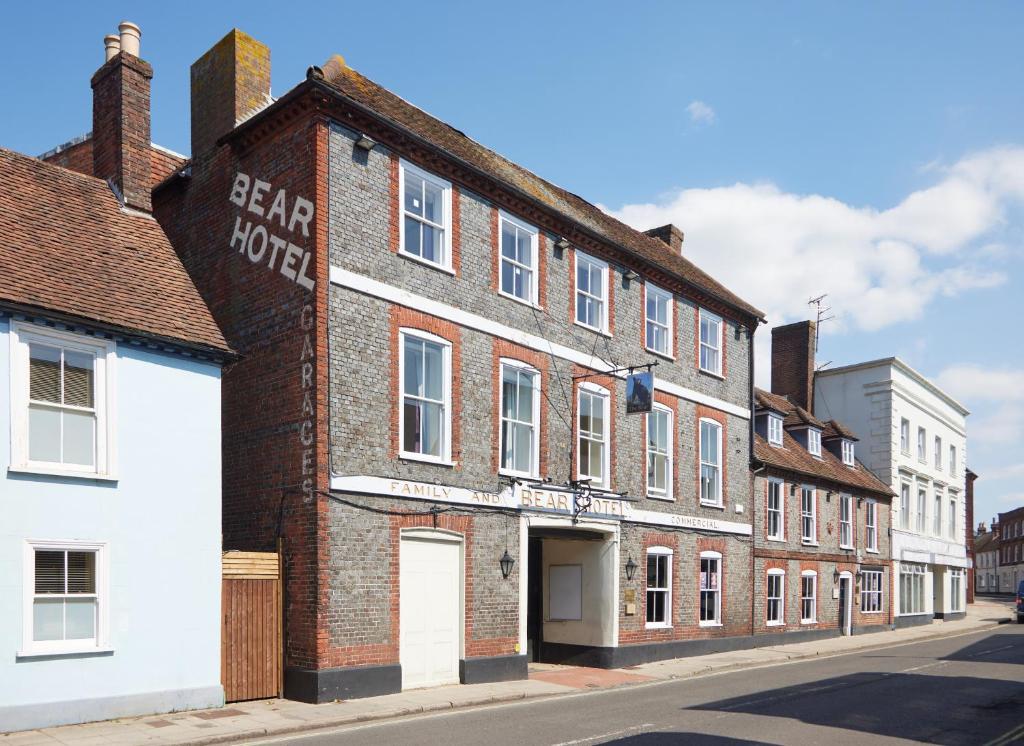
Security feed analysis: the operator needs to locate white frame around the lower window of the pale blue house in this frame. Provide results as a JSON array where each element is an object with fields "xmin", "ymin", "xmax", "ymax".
[{"xmin": 17, "ymin": 539, "xmax": 111, "ymax": 658}]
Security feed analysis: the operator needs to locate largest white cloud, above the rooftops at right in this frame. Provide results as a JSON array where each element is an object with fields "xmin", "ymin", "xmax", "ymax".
[{"xmin": 609, "ymin": 144, "xmax": 1024, "ymax": 337}]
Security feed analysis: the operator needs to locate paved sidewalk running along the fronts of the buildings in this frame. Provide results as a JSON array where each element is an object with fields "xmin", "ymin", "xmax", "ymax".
[{"xmin": 0, "ymin": 600, "xmax": 1016, "ymax": 746}]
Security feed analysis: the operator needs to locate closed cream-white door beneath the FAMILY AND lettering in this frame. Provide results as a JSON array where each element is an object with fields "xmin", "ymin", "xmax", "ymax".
[{"xmin": 398, "ymin": 537, "xmax": 462, "ymax": 689}]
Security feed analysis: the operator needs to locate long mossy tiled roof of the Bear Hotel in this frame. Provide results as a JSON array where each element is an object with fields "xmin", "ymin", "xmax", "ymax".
[{"xmin": 315, "ymin": 63, "xmax": 764, "ymax": 318}]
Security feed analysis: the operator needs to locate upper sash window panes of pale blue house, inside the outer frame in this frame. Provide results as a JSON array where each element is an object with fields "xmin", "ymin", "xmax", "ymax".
[{"xmin": 29, "ymin": 343, "xmax": 96, "ymax": 468}]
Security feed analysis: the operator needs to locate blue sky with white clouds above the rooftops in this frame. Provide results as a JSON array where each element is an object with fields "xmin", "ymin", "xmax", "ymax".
[{"xmin": 0, "ymin": 0, "xmax": 1024, "ymax": 522}]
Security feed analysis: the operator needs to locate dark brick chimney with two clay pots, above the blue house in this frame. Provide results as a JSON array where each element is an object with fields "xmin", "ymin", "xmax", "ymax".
[{"xmin": 92, "ymin": 20, "xmax": 153, "ymax": 212}]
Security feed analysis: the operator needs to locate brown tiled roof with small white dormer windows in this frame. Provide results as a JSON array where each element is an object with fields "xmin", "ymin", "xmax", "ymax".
[{"xmin": 754, "ymin": 389, "xmax": 893, "ymax": 497}]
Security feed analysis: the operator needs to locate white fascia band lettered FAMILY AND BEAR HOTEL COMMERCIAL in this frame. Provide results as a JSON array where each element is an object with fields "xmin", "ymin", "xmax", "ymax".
[{"xmin": 331, "ymin": 476, "xmax": 752, "ymax": 536}]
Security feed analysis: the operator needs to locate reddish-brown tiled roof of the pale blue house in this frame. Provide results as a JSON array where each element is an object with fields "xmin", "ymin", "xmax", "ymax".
[{"xmin": 0, "ymin": 147, "xmax": 230, "ymax": 352}]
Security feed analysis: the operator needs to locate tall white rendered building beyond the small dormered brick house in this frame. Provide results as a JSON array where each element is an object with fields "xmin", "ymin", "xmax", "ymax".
[{"xmin": 814, "ymin": 357, "xmax": 973, "ymax": 626}]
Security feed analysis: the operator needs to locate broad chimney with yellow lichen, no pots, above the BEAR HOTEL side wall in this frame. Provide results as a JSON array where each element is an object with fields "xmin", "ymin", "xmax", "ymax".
[{"xmin": 191, "ymin": 29, "xmax": 270, "ymax": 160}]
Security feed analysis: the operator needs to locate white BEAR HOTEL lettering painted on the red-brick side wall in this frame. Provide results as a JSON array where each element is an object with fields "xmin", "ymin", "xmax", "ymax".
[{"xmin": 228, "ymin": 171, "xmax": 316, "ymax": 291}]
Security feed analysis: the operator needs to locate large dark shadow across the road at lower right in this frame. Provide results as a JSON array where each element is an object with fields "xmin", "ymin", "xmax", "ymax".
[{"xmin": 686, "ymin": 671, "xmax": 1024, "ymax": 744}]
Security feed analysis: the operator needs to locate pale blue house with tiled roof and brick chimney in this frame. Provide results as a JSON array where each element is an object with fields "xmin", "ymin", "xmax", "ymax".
[{"xmin": 0, "ymin": 24, "xmax": 234, "ymax": 731}]
